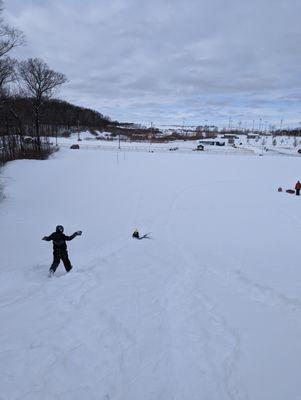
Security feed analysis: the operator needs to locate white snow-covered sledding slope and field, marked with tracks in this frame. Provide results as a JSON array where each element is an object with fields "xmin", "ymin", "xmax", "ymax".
[{"xmin": 0, "ymin": 144, "xmax": 301, "ymax": 400}]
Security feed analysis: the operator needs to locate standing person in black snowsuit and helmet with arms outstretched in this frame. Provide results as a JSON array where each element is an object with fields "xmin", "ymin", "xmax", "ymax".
[{"xmin": 42, "ymin": 225, "xmax": 82, "ymax": 275}]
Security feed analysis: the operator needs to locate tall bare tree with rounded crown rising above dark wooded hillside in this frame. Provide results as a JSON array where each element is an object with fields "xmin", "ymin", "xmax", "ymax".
[{"xmin": 18, "ymin": 58, "xmax": 67, "ymax": 138}]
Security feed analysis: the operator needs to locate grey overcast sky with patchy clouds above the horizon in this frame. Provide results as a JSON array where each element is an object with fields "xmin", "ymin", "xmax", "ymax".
[{"xmin": 5, "ymin": 0, "xmax": 301, "ymax": 126}]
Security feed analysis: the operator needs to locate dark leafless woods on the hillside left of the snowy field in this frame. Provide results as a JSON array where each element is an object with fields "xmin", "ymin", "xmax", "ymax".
[{"xmin": 0, "ymin": 96, "xmax": 117, "ymax": 165}]
